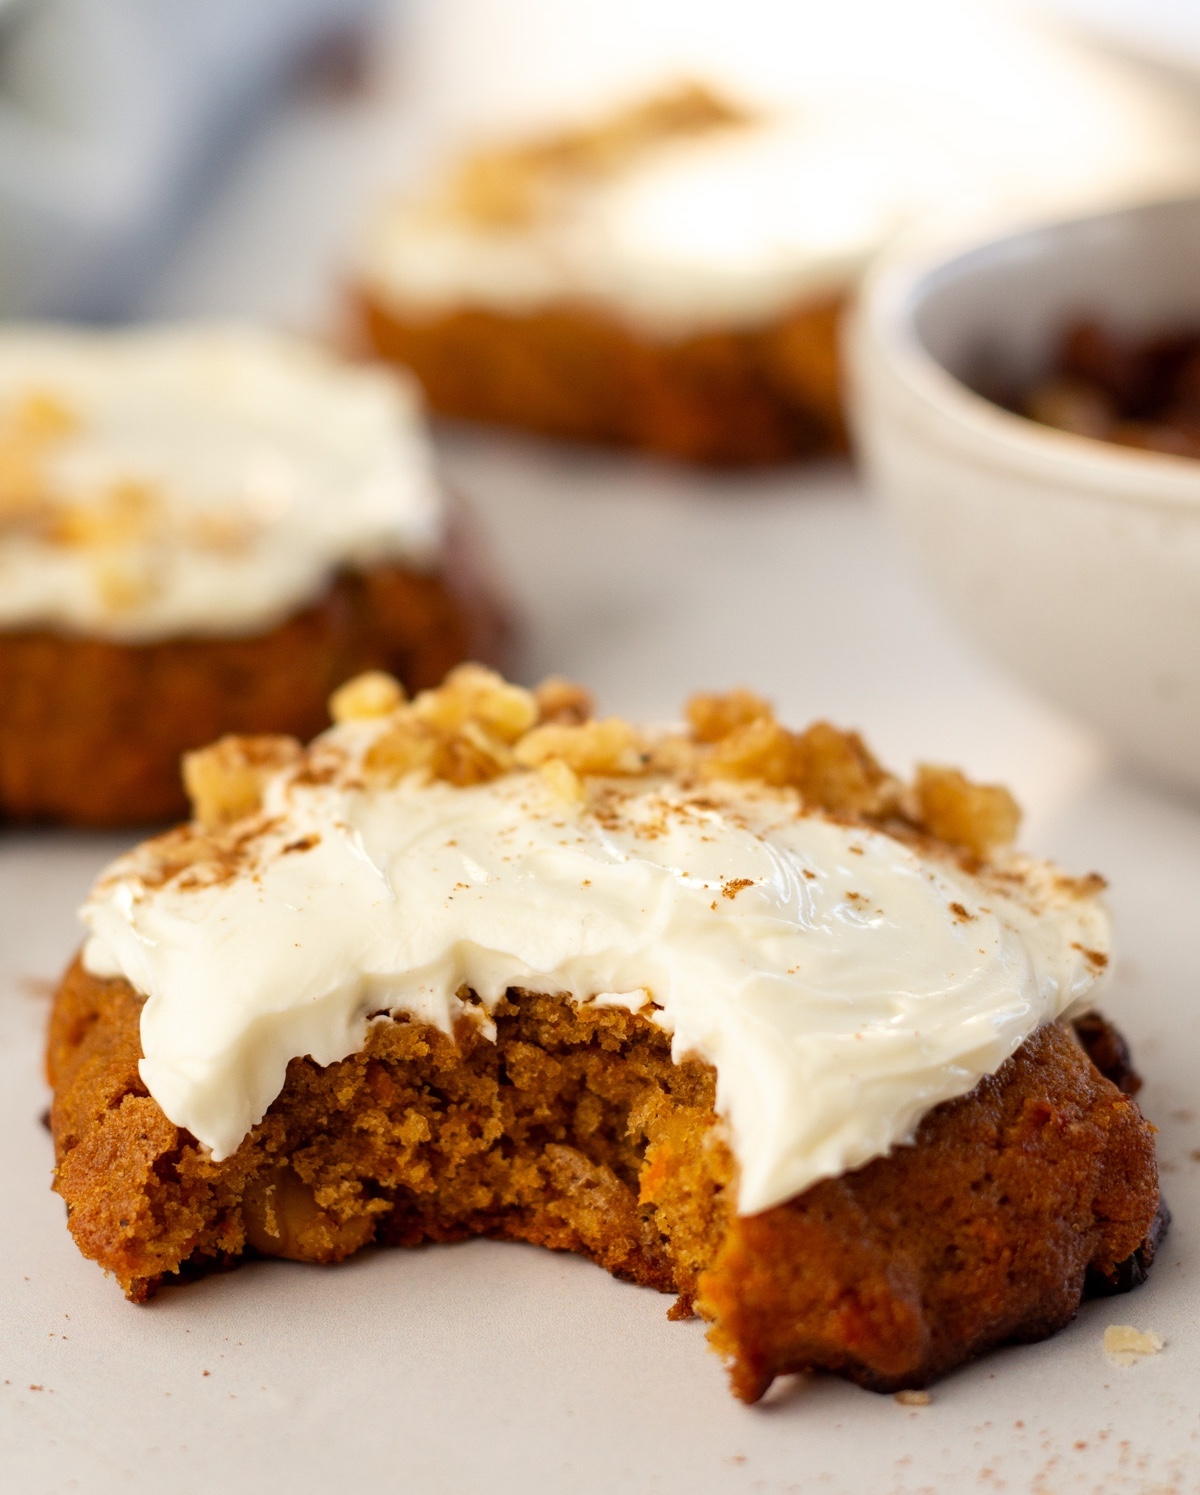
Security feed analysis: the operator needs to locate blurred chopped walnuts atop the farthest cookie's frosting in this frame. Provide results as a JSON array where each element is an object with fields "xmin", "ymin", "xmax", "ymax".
[{"xmin": 445, "ymin": 82, "xmax": 753, "ymax": 229}]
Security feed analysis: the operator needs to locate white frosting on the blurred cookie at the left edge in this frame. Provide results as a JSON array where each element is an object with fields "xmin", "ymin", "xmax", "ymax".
[{"xmin": 0, "ymin": 326, "xmax": 442, "ymax": 641}]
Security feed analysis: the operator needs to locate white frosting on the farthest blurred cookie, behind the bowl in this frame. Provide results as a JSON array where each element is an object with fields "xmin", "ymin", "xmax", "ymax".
[{"xmin": 357, "ymin": 108, "xmax": 926, "ymax": 336}]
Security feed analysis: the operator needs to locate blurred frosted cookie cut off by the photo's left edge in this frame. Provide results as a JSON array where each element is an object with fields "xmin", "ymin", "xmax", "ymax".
[{"xmin": 0, "ymin": 326, "xmax": 499, "ymax": 825}]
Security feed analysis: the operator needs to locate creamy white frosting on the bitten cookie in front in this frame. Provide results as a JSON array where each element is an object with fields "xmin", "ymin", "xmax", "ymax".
[{"xmin": 84, "ymin": 722, "xmax": 1109, "ymax": 1212}]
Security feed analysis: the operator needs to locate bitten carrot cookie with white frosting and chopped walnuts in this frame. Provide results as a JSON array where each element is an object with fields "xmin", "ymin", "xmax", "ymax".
[{"xmin": 49, "ymin": 665, "xmax": 1163, "ymax": 1401}]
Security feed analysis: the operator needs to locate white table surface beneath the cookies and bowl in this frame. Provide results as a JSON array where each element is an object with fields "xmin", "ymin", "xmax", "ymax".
[{"xmin": 0, "ymin": 14, "xmax": 1200, "ymax": 1495}]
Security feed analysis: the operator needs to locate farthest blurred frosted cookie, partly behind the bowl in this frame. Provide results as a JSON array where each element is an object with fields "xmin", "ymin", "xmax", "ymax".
[{"xmin": 354, "ymin": 85, "xmax": 916, "ymax": 463}]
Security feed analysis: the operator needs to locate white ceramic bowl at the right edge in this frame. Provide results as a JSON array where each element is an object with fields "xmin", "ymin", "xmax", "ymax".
[{"xmin": 849, "ymin": 200, "xmax": 1200, "ymax": 792}]
